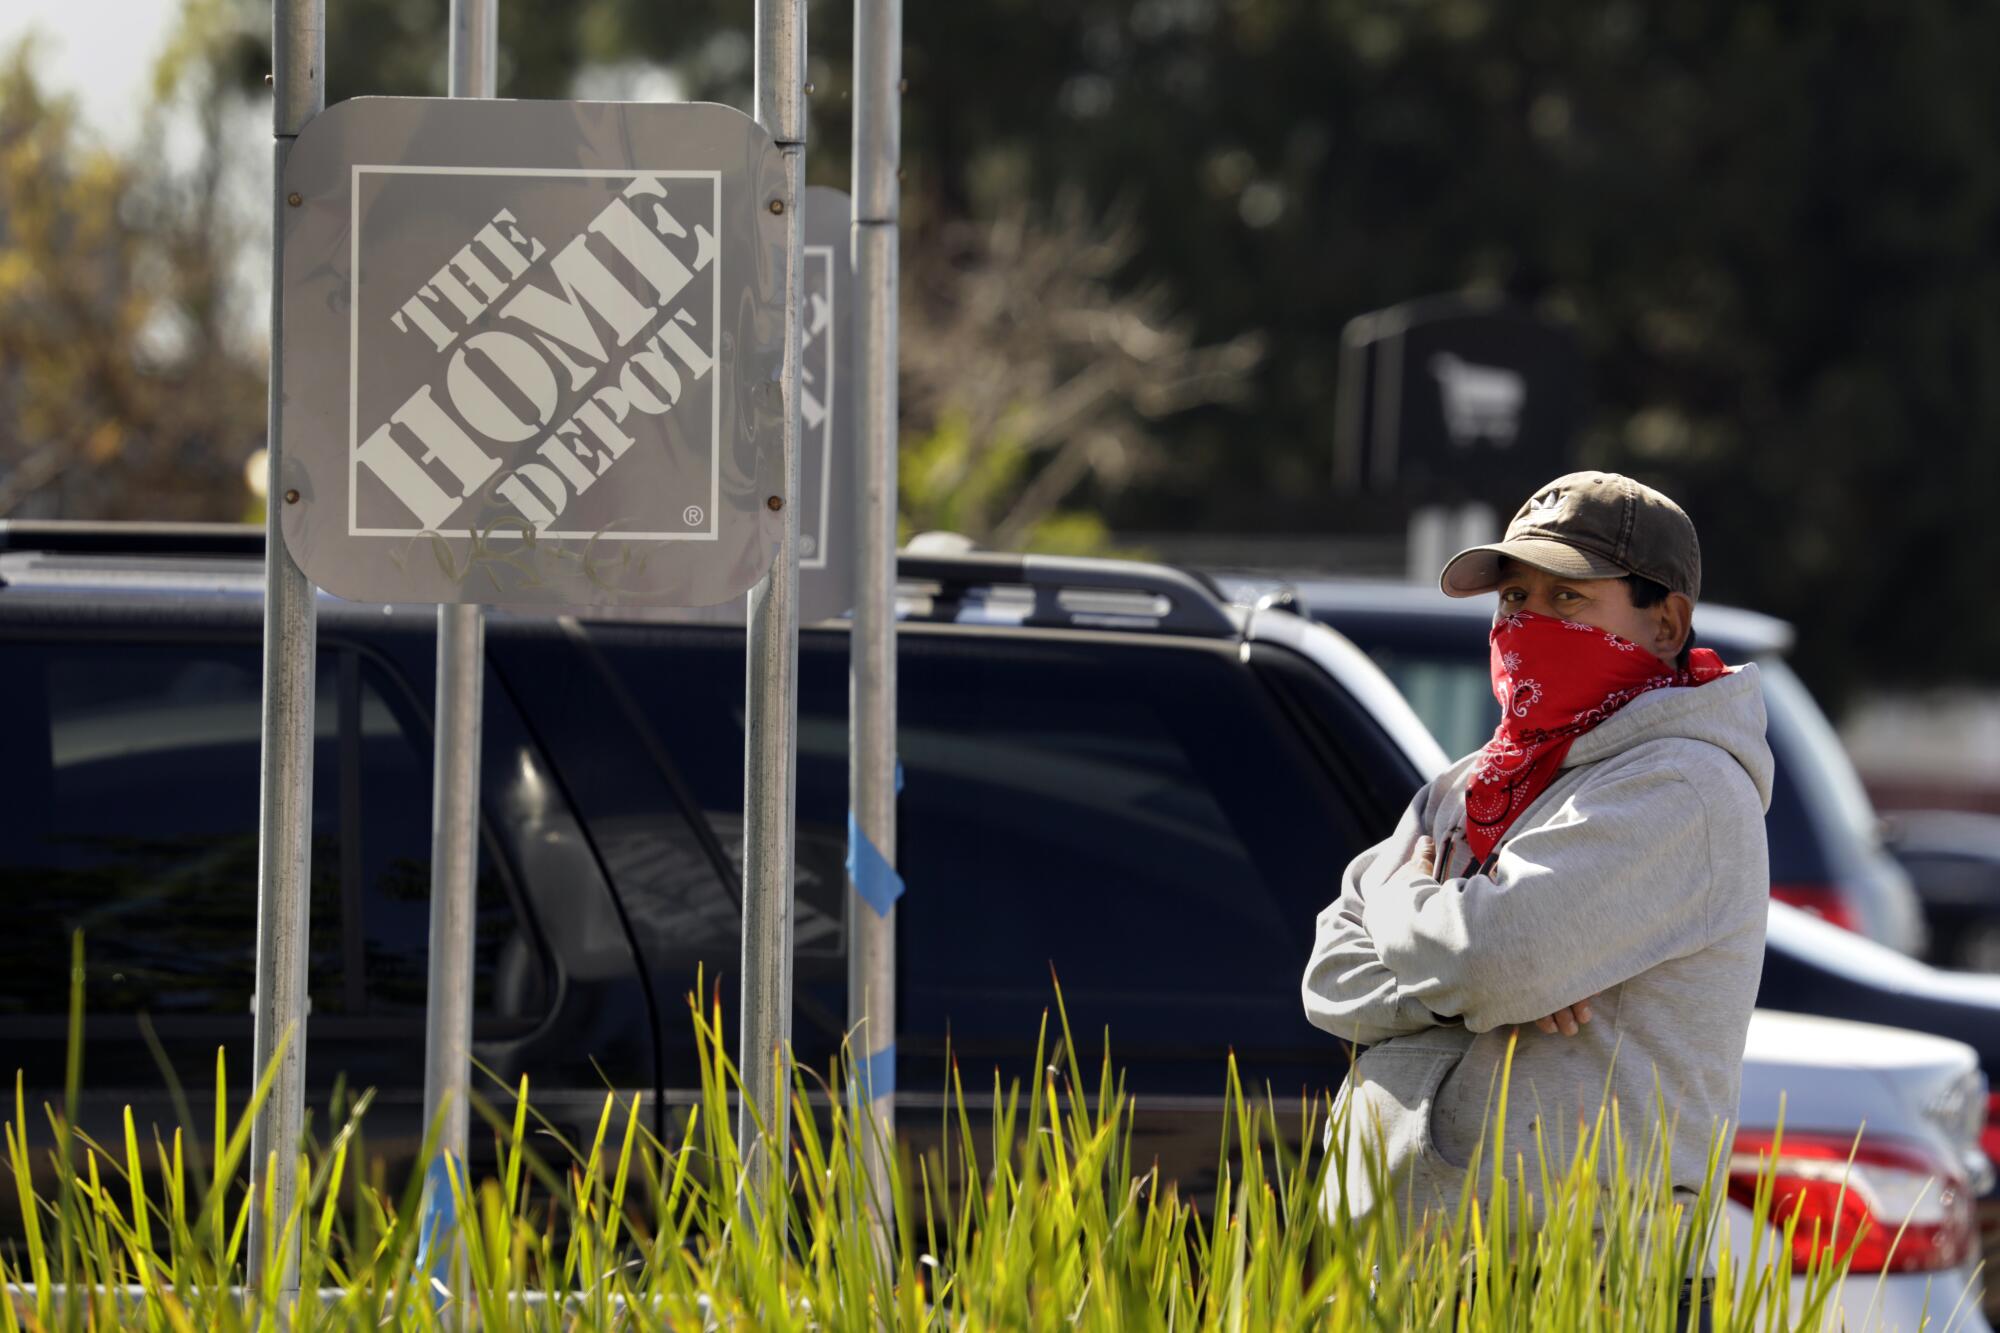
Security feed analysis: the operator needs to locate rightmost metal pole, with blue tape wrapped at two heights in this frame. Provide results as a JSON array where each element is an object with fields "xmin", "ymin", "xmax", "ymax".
[{"xmin": 848, "ymin": 0, "xmax": 902, "ymax": 1217}]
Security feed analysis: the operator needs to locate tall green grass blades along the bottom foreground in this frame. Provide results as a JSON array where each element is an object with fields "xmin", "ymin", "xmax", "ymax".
[{"xmin": 0, "ymin": 940, "xmax": 1936, "ymax": 1331}]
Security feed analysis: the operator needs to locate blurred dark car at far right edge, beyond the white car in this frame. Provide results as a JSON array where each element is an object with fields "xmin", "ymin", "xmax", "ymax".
[{"xmin": 1886, "ymin": 811, "xmax": 2000, "ymax": 973}]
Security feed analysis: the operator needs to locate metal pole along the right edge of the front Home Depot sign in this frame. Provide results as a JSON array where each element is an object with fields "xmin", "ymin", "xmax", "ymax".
[{"xmin": 736, "ymin": 0, "xmax": 806, "ymax": 1199}]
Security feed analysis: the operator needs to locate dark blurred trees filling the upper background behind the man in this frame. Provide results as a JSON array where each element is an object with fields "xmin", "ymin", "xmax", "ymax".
[{"xmin": 70, "ymin": 0, "xmax": 2000, "ymax": 695}]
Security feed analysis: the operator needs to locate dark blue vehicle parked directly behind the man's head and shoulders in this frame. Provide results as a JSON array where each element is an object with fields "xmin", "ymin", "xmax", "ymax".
[{"xmin": 1264, "ymin": 578, "xmax": 1924, "ymax": 955}]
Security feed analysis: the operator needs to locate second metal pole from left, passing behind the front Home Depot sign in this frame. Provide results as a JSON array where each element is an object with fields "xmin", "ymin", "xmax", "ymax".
[{"xmin": 422, "ymin": 0, "xmax": 498, "ymax": 1289}]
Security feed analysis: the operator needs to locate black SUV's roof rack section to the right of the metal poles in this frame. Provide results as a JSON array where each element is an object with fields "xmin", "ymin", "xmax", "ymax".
[{"xmin": 896, "ymin": 552, "xmax": 1240, "ymax": 638}]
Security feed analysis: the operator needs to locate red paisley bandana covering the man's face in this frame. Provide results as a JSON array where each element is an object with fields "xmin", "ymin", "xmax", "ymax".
[{"xmin": 1466, "ymin": 610, "xmax": 1728, "ymax": 865}]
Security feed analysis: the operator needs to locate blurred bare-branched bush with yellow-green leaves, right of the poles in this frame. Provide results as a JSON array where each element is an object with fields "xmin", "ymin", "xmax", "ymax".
[{"xmin": 900, "ymin": 194, "xmax": 1262, "ymax": 552}]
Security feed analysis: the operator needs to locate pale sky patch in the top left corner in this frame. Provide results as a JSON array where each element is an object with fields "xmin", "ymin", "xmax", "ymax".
[{"xmin": 0, "ymin": 0, "xmax": 180, "ymax": 142}]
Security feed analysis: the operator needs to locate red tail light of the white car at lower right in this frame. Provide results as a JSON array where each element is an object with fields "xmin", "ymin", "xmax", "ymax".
[{"xmin": 1730, "ymin": 1129, "xmax": 1978, "ymax": 1273}]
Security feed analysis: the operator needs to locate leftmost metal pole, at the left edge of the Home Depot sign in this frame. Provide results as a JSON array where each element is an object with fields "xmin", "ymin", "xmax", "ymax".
[{"xmin": 248, "ymin": 0, "xmax": 326, "ymax": 1305}]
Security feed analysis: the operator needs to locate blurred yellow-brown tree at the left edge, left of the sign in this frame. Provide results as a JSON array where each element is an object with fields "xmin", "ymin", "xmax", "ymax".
[{"xmin": 0, "ymin": 16, "xmax": 264, "ymax": 518}]
